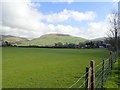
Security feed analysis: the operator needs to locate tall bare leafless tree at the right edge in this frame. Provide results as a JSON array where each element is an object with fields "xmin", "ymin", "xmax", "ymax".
[{"xmin": 106, "ymin": 10, "xmax": 120, "ymax": 51}]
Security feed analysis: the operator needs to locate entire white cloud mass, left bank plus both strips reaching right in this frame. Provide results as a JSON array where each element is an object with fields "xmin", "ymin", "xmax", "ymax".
[{"xmin": 0, "ymin": 0, "xmax": 107, "ymax": 39}]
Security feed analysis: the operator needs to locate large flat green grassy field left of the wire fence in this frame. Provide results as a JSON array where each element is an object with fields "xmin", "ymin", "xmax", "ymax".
[{"xmin": 2, "ymin": 48, "xmax": 109, "ymax": 88}]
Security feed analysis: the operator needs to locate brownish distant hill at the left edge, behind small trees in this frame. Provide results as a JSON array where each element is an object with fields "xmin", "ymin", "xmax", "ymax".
[{"xmin": 0, "ymin": 35, "xmax": 29, "ymax": 44}]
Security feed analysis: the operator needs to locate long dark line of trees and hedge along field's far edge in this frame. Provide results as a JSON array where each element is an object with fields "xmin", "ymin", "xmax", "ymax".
[{"xmin": 2, "ymin": 41, "xmax": 109, "ymax": 48}]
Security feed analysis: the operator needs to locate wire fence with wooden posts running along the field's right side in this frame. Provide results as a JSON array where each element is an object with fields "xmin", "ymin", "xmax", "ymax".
[{"xmin": 69, "ymin": 52, "xmax": 117, "ymax": 89}]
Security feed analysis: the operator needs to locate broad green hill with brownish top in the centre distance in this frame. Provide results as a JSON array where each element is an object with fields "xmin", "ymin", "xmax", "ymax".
[{"xmin": 21, "ymin": 34, "xmax": 87, "ymax": 46}]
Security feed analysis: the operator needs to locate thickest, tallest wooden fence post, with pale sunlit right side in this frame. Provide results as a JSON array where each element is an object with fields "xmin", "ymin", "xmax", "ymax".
[{"xmin": 90, "ymin": 60, "xmax": 95, "ymax": 90}]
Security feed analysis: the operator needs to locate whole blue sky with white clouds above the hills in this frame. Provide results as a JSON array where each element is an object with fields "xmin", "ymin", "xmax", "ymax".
[{"xmin": 0, "ymin": 0, "xmax": 117, "ymax": 39}]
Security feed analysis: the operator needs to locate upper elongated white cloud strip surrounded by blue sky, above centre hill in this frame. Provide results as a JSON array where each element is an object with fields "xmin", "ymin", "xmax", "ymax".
[{"xmin": 44, "ymin": 9, "xmax": 96, "ymax": 23}]
